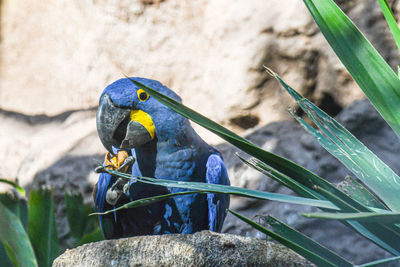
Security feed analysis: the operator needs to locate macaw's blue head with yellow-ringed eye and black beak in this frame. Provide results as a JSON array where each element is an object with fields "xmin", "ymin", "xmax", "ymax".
[{"xmin": 96, "ymin": 77, "xmax": 186, "ymax": 153}]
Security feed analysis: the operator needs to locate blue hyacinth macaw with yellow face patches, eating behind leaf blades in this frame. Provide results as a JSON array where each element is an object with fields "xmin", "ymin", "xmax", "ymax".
[{"xmin": 94, "ymin": 78, "xmax": 230, "ymax": 239}]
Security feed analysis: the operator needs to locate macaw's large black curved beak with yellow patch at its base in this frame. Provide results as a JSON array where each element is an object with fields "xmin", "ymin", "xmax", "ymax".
[{"xmin": 96, "ymin": 94, "xmax": 154, "ymax": 154}]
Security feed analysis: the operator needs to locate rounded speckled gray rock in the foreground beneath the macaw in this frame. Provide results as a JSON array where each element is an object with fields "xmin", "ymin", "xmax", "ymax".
[{"xmin": 53, "ymin": 231, "xmax": 314, "ymax": 267}]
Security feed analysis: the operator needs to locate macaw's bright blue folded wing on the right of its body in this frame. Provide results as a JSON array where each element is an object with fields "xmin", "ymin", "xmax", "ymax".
[{"xmin": 206, "ymin": 154, "xmax": 230, "ymax": 232}]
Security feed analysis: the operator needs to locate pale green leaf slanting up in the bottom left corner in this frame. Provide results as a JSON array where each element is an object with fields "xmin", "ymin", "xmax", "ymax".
[{"xmin": 0, "ymin": 202, "xmax": 38, "ymax": 267}]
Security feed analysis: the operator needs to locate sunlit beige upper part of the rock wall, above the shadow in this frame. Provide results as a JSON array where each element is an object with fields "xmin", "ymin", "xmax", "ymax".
[{"xmin": 0, "ymin": 0, "xmax": 398, "ymax": 129}]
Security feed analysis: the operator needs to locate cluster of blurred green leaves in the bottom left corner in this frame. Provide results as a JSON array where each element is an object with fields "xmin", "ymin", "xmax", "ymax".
[{"xmin": 0, "ymin": 186, "xmax": 103, "ymax": 266}]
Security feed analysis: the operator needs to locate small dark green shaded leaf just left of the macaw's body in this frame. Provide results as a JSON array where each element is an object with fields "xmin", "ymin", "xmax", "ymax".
[{"xmin": 65, "ymin": 193, "xmax": 88, "ymax": 240}]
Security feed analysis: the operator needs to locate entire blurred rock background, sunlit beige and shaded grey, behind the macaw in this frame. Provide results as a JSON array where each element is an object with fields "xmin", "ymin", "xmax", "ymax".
[{"xmin": 0, "ymin": 0, "xmax": 400, "ymax": 261}]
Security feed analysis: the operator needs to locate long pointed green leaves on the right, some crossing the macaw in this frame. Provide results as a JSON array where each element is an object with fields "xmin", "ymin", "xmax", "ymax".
[{"xmin": 122, "ymin": 0, "xmax": 400, "ymax": 266}]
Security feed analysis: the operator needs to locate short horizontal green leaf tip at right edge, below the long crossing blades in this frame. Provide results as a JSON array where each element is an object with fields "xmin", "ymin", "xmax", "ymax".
[{"xmin": 303, "ymin": 212, "xmax": 400, "ymax": 224}]
